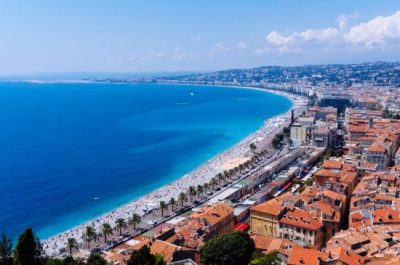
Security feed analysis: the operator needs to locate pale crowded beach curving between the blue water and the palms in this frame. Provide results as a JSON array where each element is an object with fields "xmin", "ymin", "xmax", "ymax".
[{"xmin": 42, "ymin": 84, "xmax": 305, "ymax": 256}]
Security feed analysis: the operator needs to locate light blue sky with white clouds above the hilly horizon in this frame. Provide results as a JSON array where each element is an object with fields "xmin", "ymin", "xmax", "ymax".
[{"xmin": 0, "ymin": 0, "xmax": 400, "ymax": 76}]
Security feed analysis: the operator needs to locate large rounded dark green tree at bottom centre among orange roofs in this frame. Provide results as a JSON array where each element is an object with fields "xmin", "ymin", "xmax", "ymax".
[{"xmin": 200, "ymin": 232, "xmax": 255, "ymax": 265}]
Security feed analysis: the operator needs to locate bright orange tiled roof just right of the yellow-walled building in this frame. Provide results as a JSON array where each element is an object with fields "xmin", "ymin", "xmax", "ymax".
[{"xmin": 279, "ymin": 208, "xmax": 322, "ymax": 231}]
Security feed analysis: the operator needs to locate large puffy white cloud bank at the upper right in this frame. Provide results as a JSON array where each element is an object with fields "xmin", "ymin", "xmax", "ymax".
[{"xmin": 266, "ymin": 11, "xmax": 400, "ymax": 52}]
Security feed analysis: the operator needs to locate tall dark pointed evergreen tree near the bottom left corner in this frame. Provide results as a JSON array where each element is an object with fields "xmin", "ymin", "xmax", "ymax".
[{"xmin": 14, "ymin": 228, "xmax": 42, "ymax": 265}]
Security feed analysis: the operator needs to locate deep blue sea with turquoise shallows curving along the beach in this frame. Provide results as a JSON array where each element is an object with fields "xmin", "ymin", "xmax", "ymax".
[{"xmin": 0, "ymin": 83, "xmax": 291, "ymax": 239}]
